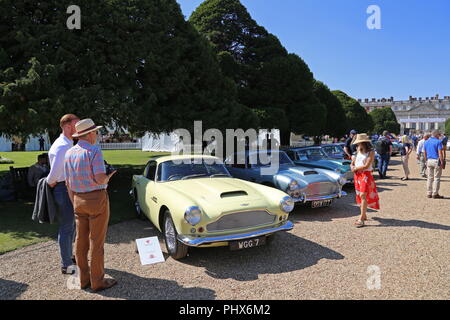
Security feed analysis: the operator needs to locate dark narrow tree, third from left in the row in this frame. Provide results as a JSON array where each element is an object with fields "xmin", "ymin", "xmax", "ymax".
[{"xmin": 314, "ymin": 81, "xmax": 348, "ymax": 137}]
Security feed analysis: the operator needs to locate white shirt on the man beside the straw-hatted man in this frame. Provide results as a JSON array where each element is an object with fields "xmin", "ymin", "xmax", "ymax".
[{"xmin": 47, "ymin": 133, "xmax": 73, "ymax": 184}]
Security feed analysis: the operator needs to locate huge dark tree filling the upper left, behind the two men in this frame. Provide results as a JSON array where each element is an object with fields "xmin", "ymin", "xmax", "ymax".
[{"xmin": 0, "ymin": 0, "xmax": 257, "ymax": 141}]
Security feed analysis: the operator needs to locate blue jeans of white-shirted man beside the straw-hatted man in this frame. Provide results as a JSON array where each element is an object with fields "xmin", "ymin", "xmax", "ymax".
[{"xmin": 53, "ymin": 183, "xmax": 75, "ymax": 267}]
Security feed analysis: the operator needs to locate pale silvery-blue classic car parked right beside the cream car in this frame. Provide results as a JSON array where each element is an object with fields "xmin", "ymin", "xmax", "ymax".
[{"xmin": 225, "ymin": 151, "xmax": 347, "ymax": 208}]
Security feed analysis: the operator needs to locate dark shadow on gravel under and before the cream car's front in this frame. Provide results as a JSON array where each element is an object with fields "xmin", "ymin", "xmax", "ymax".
[{"xmin": 180, "ymin": 232, "xmax": 344, "ymax": 282}]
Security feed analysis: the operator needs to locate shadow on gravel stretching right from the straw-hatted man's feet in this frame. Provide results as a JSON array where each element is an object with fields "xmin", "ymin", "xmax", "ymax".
[{"xmin": 87, "ymin": 269, "xmax": 216, "ymax": 300}]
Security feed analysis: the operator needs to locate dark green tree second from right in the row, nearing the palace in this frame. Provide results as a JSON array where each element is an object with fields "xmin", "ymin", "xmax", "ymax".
[{"xmin": 332, "ymin": 90, "xmax": 374, "ymax": 133}]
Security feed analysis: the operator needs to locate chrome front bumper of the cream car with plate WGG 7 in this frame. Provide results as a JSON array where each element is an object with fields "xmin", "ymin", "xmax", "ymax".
[{"xmin": 177, "ymin": 220, "xmax": 294, "ymax": 247}]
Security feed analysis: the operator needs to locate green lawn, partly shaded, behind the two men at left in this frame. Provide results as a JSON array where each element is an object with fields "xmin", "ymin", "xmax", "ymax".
[{"xmin": 0, "ymin": 150, "xmax": 169, "ymax": 254}]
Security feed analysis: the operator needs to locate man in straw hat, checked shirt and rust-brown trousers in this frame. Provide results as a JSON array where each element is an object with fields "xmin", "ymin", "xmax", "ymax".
[{"xmin": 64, "ymin": 119, "xmax": 117, "ymax": 291}]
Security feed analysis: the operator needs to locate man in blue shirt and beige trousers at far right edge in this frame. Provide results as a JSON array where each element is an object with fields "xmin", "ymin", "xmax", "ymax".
[{"xmin": 423, "ymin": 130, "xmax": 445, "ymax": 199}]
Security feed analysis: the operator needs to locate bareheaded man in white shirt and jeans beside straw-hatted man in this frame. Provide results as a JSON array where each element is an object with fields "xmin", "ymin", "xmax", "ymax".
[{"xmin": 47, "ymin": 114, "xmax": 80, "ymax": 274}]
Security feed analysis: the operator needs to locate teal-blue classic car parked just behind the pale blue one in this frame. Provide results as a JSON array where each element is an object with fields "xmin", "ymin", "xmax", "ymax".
[{"xmin": 286, "ymin": 146, "xmax": 354, "ymax": 183}]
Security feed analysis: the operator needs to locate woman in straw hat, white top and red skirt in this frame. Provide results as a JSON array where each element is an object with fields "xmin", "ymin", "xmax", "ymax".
[{"xmin": 351, "ymin": 133, "xmax": 380, "ymax": 228}]
